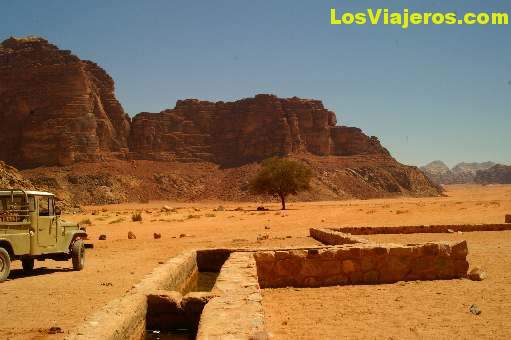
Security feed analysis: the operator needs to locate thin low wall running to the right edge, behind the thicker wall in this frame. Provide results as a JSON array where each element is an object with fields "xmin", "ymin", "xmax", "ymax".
[{"xmin": 327, "ymin": 224, "xmax": 511, "ymax": 235}]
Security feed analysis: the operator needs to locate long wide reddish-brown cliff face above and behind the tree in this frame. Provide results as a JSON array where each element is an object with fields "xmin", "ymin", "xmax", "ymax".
[{"xmin": 129, "ymin": 94, "xmax": 388, "ymax": 165}]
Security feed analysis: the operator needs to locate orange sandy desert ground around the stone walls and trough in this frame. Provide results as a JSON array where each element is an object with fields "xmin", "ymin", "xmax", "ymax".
[{"xmin": 0, "ymin": 186, "xmax": 511, "ymax": 339}]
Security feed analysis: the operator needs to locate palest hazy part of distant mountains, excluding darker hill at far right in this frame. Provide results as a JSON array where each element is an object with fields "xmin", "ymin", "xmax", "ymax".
[{"xmin": 421, "ymin": 161, "xmax": 495, "ymax": 184}]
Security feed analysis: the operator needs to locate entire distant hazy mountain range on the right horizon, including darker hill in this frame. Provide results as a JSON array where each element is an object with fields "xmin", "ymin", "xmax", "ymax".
[{"xmin": 421, "ymin": 161, "xmax": 511, "ymax": 184}]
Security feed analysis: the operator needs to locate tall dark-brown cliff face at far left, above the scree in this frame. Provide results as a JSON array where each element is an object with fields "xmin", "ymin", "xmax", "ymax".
[{"xmin": 0, "ymin": 38, "xmax": 129, "ymax": 168}]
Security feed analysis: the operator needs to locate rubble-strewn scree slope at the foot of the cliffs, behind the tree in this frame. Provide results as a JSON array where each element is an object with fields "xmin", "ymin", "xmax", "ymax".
[{"xmin": 22, "ymin": 153, "xmax": 441, "ymax": 204}]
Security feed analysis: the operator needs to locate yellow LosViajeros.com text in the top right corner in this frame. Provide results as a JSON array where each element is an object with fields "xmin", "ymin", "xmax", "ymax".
[{"xmin": 330, "ymin": 8, "xmax": 509, "ymax": 29}]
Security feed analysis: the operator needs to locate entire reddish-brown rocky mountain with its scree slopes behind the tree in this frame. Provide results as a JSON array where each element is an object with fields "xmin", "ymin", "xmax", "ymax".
[{"xmin": 0, "ymin": 38, "xmax": 441, "ymax": 203}]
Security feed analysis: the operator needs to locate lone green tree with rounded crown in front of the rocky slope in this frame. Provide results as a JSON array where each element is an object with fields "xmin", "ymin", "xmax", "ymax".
[{"xmin": 250, "ymin": 157, "xmax": 312, "ymax": 210}]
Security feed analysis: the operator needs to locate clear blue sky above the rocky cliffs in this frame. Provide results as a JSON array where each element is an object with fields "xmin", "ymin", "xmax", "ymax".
[{"xmin": 0, "ymin": 0, "xmax": 511, "ymax": 166}]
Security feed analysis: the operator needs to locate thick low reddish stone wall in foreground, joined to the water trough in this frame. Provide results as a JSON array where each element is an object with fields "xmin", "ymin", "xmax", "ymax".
[{"xmin": 254, "ymin": 241, "xmax": 469, "ymax": 288}]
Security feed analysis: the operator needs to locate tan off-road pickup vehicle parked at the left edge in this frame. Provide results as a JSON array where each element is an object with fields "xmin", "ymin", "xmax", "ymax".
[{"xmin": 0, "ymin": 189, "xmax": 87, "ymax": 282}]
